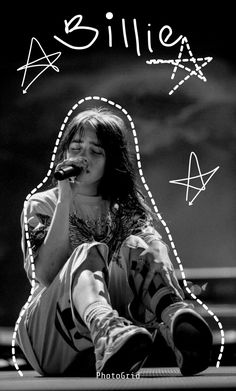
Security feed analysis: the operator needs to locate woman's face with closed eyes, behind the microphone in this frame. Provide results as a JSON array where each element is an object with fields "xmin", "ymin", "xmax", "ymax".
[{"xmin": 66, "ymin": 124, "xmax": 106, "ymax": 185}]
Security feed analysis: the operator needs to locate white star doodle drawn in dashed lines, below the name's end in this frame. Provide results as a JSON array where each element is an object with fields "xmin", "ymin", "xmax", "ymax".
[{"xmin": 146, "ymin": 37, "xmax": 213, "ymax": 95}]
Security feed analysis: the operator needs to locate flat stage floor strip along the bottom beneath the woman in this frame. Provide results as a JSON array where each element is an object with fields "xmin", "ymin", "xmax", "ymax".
[{"xmin": 0, "ymin": 366, "xmax": 236, "ymax": 391}]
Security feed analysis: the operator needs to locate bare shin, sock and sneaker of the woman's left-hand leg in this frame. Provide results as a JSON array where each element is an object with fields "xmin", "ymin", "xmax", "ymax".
[{"xmin": 69, "ymin": 246, "xmax": 152, "ymax": 373}]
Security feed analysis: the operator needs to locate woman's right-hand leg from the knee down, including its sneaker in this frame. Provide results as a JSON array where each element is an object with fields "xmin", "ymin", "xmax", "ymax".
[{"xmin": 125, "ymin": 236, "xmax": 212, "ymax": 375}]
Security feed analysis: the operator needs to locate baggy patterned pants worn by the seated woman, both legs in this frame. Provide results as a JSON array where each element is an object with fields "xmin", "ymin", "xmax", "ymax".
[{"xmin": 17, "ymin": 235, "xmax": 182, "ymax": 376}]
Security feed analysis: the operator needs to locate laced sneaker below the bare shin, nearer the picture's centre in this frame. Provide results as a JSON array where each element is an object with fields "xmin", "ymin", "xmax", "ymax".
[{"xmin": 91, "ymin": 311, "xmax": 153, "ymax": 374}]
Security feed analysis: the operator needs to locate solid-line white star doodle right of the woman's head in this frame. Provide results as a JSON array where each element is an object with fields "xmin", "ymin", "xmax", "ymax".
[{"xmin": 169, "ymin": 152, "xmax": 219, "ymax": 206}]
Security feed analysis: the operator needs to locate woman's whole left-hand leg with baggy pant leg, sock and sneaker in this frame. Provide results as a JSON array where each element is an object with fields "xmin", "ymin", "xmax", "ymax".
[{"xmin": 19, "ymin": 243, "xmax": 152, "ymax": 376}]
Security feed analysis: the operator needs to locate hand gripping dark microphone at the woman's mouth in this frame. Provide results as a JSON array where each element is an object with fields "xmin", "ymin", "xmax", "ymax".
[{"xmin": 54, "ymin": 159, "xmax": 88, "ymax": 181}]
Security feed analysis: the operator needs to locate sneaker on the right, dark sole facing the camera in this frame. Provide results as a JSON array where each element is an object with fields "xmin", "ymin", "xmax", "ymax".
[{"xmin": 159, "ymin": 303, "xmax": 213, "ymax": 376}]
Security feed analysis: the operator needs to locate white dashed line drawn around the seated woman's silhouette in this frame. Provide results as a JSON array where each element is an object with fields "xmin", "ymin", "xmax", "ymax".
[{"xmin": 12, "ymin": 96, "xmax": 224, "ymax": 376}]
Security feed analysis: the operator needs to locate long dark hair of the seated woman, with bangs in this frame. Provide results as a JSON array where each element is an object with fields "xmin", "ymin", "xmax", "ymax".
[{"xmin": 55, "ymin": 108, "xmax": 155, "ymax": 220}]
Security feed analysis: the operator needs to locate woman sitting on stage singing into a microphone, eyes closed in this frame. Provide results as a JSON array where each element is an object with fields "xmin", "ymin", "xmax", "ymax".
[{"xmin": 17, "ymin": 108, "xmax": 212, "ymax": 376}]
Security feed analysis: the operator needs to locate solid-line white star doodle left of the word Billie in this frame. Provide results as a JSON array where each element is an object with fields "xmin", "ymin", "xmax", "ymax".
[{"xmin": 17, "ymin": 37, "xmax": 61, "ymax": 94}]
